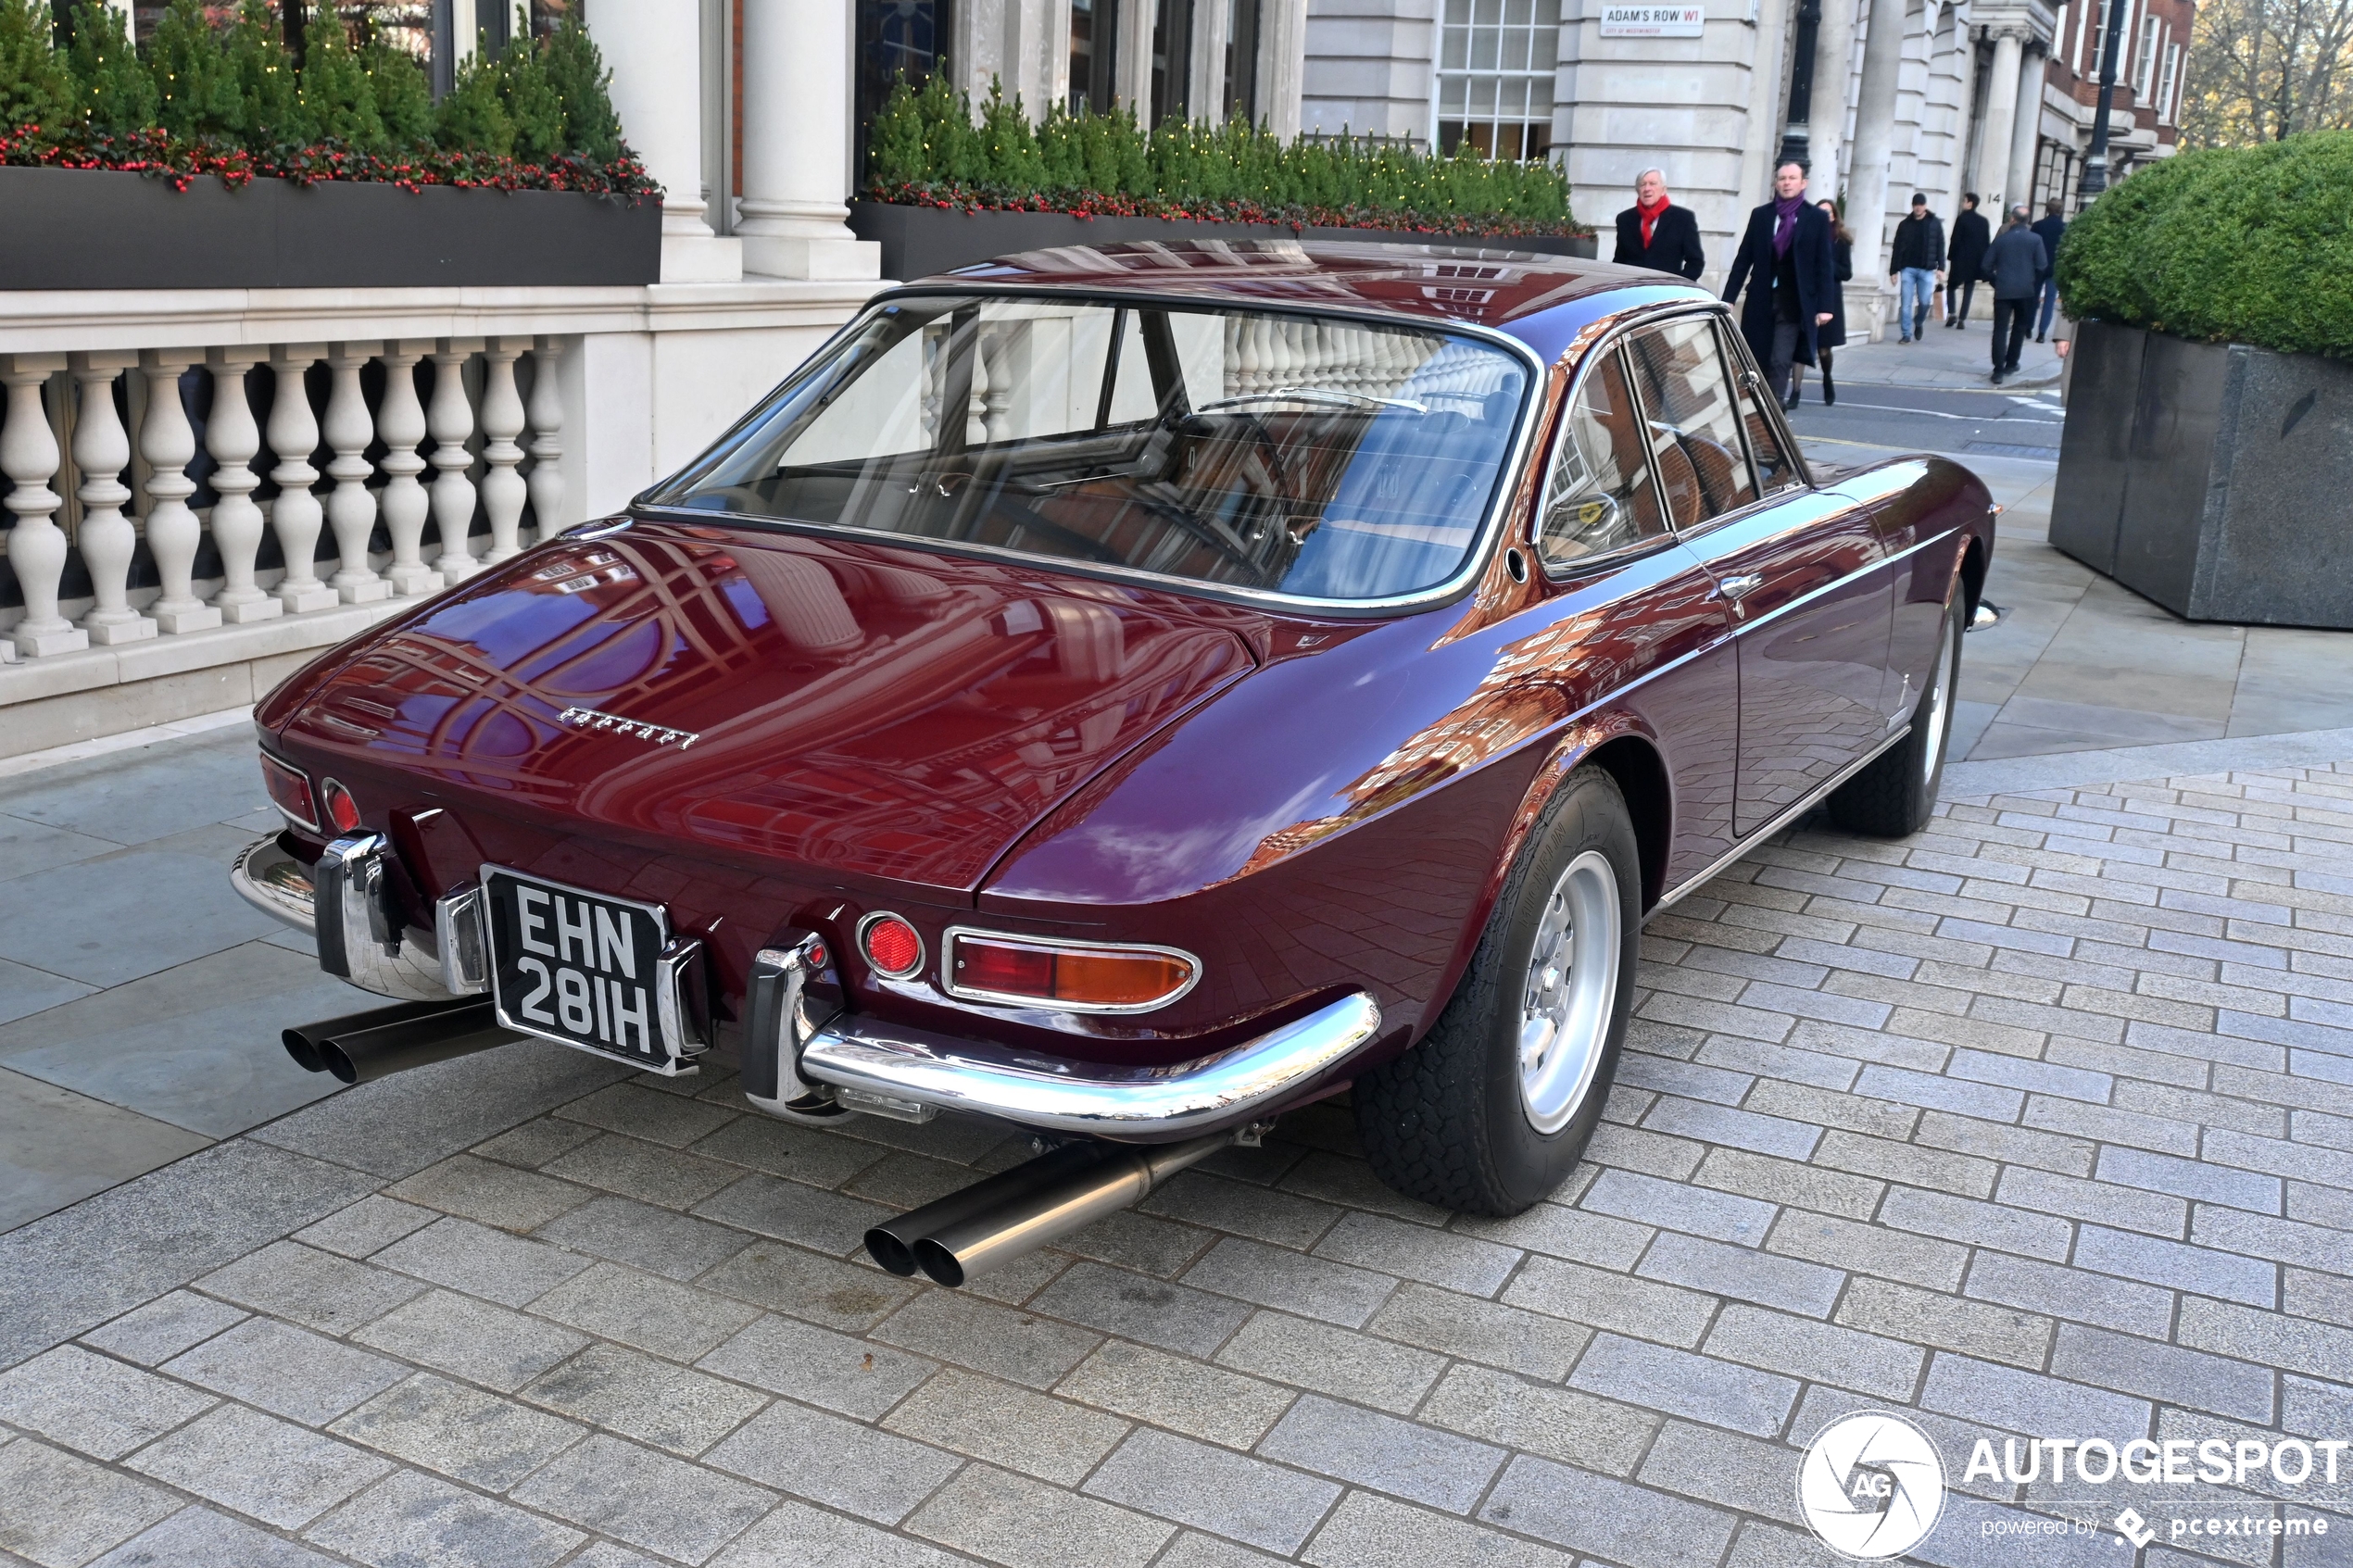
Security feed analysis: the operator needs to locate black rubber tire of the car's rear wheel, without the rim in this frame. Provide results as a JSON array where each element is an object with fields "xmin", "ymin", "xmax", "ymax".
[{"xmin": 1353, "ymin": 766, "xmax": 1642, "ymax": 1215}]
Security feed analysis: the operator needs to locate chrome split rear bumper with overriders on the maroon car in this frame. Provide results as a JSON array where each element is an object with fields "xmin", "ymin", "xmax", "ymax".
[{"xmin": 228, "ymin": 833, "xmax": 1381, "ymax": 1143}]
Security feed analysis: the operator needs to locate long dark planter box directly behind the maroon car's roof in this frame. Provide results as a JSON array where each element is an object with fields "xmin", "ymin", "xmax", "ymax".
[{"xmin": 849, "ymin": 202, "xmax": 1593, "ymax": 280}]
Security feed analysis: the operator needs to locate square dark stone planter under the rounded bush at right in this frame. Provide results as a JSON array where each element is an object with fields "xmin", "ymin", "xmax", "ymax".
[{"xmin": 2049, "ymin": 322, "xmax": 2353, "ymax": 630}]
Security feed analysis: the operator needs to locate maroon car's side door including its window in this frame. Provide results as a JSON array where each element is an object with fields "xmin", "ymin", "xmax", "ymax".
[{"xmin": 1626, "ymin": 313, "xmax": 1894, "ymax": 837}]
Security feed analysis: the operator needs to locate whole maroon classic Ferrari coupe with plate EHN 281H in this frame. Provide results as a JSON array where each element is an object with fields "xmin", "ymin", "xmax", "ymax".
[{"xmin": 235, "ymin": 242, "xmax": 1995, "ymax": 1284}]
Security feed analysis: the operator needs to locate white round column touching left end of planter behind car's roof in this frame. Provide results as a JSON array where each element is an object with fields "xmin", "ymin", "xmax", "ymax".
[{"xmin": 734, "ymin": 0, "xmax": 883, "ymax": 278}]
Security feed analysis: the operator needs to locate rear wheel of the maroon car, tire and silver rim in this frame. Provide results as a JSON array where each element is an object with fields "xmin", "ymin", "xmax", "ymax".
[{"xmin": 1353, "ymin": 769, "xmax": 1642, "ymax": 1215}]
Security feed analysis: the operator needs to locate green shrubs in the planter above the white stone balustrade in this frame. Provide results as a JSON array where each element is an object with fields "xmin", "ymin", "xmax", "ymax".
[{"xmin": 0, "ymin": 0, "xmax": 645, "ymax": 188}]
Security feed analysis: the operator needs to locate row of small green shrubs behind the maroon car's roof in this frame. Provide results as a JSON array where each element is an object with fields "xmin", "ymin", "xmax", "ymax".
[{"xmin": 868, "ymin": 73, "xmax": 1581, "ymax": 232}]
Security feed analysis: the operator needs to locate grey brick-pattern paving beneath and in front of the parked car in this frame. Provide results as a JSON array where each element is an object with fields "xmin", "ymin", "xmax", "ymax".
[{"xmin": 0, "ymin": 764, "xmax": 2353, "ymax": 1568}]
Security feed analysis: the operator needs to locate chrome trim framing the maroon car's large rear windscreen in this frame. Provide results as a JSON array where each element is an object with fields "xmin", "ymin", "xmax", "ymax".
[{"xmin": 628, "ymin": 282, "xmax": 1553, "ymax": 621}]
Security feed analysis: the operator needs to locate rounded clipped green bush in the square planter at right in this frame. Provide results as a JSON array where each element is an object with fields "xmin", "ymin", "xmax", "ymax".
[{"xmin": 2057, "ymin": 132, "xmax": 2353, "ymax": 358}]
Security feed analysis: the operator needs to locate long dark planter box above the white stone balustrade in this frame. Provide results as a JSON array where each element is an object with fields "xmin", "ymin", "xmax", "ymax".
[{"xmin": 0, "ymin": 169, "xmax": 661, "ymax": 289}]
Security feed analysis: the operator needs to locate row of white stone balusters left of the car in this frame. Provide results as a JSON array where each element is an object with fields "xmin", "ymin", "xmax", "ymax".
[{"xmin": 0, "ymin": 336, "xmax": 579, "ymax": 663}]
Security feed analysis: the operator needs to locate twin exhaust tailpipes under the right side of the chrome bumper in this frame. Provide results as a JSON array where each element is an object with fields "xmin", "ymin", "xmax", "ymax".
[{"xmin": 866, "ymin": 1133, "xmax": 1233, "ymax": 1288}]
